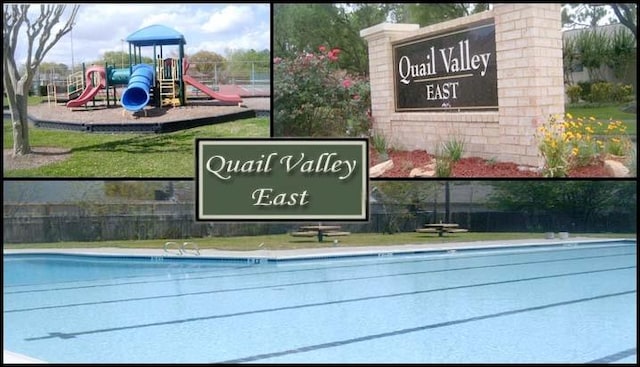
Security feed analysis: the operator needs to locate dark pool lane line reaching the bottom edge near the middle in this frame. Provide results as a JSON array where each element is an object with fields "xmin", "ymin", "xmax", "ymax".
[{"xmin": 219, "ymin": 290, "xmax": 636, "ymax": 363}]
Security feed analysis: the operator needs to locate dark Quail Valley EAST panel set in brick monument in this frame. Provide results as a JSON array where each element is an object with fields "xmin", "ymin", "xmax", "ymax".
[{"xmin": 393, "ymin": 22, "xmax": 498, "ymax": 112}]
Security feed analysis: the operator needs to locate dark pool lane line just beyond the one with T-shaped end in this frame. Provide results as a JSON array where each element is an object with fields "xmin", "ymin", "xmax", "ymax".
[{"xmin": 3, "ymin": 254, "xmax": 636, "ymax": 313}]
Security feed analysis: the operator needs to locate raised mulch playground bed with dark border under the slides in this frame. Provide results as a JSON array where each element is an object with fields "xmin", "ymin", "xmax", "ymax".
[{"xmin": 21, "ymin": 97, "xmax": 271, "ymax": 133}]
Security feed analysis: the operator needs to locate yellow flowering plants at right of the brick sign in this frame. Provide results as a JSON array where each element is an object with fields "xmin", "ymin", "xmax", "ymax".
[{"xmin": 538, "ymin": 113, "xmax": 632, "ymax": 177}]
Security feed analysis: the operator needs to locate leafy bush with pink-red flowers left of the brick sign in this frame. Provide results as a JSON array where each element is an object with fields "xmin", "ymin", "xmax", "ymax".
[{"xmin": 273, "ymin": 46, "xmax": 371, "ymax": 136}]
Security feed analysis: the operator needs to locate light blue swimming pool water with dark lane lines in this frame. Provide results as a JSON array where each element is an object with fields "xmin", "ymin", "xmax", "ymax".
[{"xmin": 3, "ymin": 241, "xmax": 637, "ymax": 363}]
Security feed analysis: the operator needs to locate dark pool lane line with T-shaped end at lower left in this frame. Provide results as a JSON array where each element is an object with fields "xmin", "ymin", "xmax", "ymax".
[{"xmin": 24, "ymin": 266, "xmax": 636, "ymax": 341}]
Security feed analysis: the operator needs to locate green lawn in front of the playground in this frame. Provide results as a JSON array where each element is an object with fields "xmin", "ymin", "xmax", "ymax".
[{"xmin": 3, "ymin": 118, "xmax": 270, "ymax": 178}]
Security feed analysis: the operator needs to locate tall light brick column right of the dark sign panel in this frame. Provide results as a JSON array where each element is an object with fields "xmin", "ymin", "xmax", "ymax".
[{"xmin": 493, "ymin": 4, "xmax": 564, "ymax": 167}]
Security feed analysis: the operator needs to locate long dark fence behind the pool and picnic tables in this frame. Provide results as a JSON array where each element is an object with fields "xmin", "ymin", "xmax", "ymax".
[{"xmin": 3, "ymin": 203, "xmax": 636, "ymax": 243}]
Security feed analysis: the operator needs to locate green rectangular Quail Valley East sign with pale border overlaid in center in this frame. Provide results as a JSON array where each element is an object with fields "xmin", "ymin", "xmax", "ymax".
[{"xmin": 196, "ymin": 138, "xmax": 369, "ymax": 221}]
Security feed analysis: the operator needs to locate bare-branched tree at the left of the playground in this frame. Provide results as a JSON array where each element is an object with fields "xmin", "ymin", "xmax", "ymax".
[{"xmin": 2, "ymin": 4, "xmax": 80, "ymax": 155}]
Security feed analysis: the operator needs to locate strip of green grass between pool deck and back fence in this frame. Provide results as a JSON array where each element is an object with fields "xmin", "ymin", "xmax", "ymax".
[{"xmin": 4, "ymin": 232, "xmax": 636, "ymax": 251}]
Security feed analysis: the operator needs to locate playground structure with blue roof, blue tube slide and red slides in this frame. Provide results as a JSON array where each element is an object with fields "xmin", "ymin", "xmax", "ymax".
[{"xmin": 66, "ymin": 25, "xmax": 242, "ymax": 112}]
